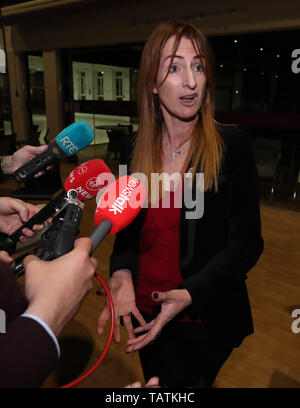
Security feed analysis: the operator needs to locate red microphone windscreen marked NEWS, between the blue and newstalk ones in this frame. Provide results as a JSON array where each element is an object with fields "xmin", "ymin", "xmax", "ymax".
[{"xmin": 64, "ymin": 159, "xmax": 114, "ymax": 201}]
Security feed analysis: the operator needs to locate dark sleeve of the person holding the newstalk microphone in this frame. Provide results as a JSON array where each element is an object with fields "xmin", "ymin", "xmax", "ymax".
[{"xmin": 0, "ymin": 262, "xmax": 58, "ymax": 387}]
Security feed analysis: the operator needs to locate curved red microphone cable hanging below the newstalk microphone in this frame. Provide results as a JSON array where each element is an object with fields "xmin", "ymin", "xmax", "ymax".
[{"xmin": 59, "ymin": 273, "xmax": 115, "ymax": 388}]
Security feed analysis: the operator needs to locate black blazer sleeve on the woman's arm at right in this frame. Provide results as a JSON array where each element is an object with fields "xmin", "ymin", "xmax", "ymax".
[{"xmin": 180, "ymin": 131, "xmax": 263, "ymax": 313}]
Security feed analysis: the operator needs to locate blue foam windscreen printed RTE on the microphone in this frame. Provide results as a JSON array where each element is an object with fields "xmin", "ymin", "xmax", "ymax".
[{"xmin": 55, "ymin": 120, "xmax": 94, "ymax": 156}]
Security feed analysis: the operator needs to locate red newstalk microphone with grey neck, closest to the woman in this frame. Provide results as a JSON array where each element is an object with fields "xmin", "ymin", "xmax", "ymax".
[{"xmin": 90, "ymin": 175, "xmax": 147, "ymax": 253}]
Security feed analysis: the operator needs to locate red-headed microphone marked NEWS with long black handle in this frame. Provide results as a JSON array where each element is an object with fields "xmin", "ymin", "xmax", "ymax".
[{"xmin": 0, "ymin": 159, "xmax": 115, "ymax": 255}]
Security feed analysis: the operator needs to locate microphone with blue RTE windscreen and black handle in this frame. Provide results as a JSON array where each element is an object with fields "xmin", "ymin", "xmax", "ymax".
[{"xmin": 13, "ymin": 121, "xmax": 94, "ymax": 181}]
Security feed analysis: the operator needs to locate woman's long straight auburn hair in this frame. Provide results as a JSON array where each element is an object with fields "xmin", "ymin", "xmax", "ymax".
[{"xmin": 131, "ymin": 21, "xmax": 224, "ymax": 199}]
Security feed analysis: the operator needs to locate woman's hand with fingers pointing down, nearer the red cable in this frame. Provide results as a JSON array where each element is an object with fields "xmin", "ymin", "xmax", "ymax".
[{"xmin": 98, "ymin": 270, "xmax": 146, "ymax": 343}]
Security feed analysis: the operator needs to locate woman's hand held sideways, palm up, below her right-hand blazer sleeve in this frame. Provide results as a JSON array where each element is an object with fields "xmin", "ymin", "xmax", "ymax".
[{"xmin": 126, "ymin": 289, "xmax": 192, "ymax": 353}]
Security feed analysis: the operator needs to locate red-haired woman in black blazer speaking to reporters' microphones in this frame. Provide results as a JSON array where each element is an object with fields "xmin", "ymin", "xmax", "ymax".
[{"xmin": 98, "ymin": 22, "xmax": 263, "ymax": 387}]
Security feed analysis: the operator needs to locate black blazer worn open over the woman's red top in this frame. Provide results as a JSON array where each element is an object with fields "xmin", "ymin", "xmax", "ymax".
[{"xmin": 110, "ymin": 126, "xmax": 263, "ymax": 348}]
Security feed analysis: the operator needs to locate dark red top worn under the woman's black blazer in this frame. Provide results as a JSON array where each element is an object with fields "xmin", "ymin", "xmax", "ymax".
[{"xmin": 136, "ymin": 186, "xmax": 200, "ymax": 321}]
